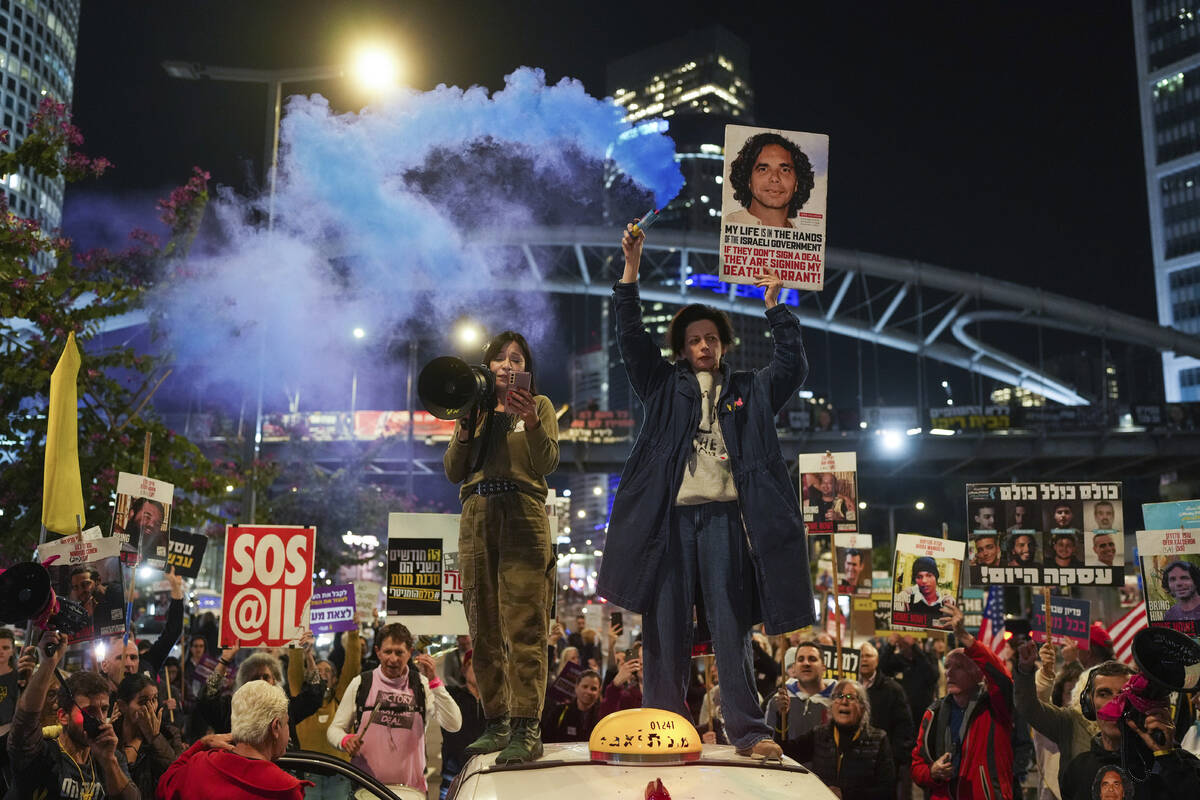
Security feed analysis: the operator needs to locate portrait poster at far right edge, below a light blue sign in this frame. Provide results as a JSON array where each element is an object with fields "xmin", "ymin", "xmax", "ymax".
[{"xmin": 1138, "ymin": 528, "xmax": 1200, "ymax": 639}]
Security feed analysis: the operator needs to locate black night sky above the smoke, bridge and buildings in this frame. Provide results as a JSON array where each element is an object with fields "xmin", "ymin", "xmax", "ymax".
[{"xmin": 66, "ymin": 0, "xmax": 1156, "ymax": 318}]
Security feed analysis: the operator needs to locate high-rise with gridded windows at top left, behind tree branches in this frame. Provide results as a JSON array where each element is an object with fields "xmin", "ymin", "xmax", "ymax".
[{"xmin": 0, "ymin": 0, "xmax": 80, "ymax": 229}]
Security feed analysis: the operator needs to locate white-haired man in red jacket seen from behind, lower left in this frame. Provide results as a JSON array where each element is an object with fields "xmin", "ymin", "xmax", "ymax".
[{"xmin": 157, "ymin": 680, "xmax": 312, "ymax": 800}]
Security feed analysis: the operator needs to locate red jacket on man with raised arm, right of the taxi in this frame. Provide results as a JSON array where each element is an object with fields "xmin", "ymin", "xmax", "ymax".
[{"xmin": 912, "ymin": 640, "xmax": 1013, "ymax": 800}]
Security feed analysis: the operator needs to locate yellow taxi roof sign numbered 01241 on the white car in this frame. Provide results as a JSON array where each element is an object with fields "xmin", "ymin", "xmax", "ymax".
[{"xmin": 588, "ymin": 709, "xmax": 702, "ymax": 764}]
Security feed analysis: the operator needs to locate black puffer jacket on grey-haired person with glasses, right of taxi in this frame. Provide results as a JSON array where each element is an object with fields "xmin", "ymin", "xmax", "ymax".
[{"xmin": 776, "ymin": 722, "xmax": 896, "ymax": 800}]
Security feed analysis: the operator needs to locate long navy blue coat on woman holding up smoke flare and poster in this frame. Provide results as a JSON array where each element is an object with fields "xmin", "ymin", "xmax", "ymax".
[{"xmin": 596, "ymin": 283, "xmax": 812, "ymax": 634}]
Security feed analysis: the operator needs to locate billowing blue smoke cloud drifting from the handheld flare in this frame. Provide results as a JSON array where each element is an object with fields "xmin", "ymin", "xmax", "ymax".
[{"xmin": 157, "ymin": 67, "xmax": 683, "ymax": 408}]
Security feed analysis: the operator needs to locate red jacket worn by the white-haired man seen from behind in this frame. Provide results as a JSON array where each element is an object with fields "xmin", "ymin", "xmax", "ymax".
[{"xmin": 155, "ymin": 741, "xmax": 312, "ymax": 800}]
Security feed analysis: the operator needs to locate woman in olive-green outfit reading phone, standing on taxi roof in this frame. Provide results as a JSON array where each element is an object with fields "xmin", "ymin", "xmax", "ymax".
[{"xmin": 444, "ymin": 331, "xmax": 558, "ymax": 764}]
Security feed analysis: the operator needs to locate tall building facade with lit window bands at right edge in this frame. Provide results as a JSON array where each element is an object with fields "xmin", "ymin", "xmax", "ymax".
[{"xmin": 1133, "ymin": 0, "xmax": 1200, "ymax": 402}]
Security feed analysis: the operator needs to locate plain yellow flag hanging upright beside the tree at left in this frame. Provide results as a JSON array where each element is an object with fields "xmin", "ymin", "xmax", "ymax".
[{"xmin": 42, "ymin": 333, "xmax": 83, "ymax": 535}]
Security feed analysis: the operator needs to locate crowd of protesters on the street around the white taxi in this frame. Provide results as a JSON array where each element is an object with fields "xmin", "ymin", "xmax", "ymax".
[{"xmin": 7, "ymin": 606, "xmax": 1200, "ymax": 800}]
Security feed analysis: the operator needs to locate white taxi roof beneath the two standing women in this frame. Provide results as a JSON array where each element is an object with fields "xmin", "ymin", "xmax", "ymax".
[{"xmin": 450, "ymin": 741, "xmax": 834, "ymax": 800}]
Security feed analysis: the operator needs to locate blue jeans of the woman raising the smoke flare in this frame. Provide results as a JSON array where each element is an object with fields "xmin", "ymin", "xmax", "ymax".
[{"xmin": 642, "ymin": 503, "xmax": 772, "ymax": 747}]
